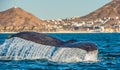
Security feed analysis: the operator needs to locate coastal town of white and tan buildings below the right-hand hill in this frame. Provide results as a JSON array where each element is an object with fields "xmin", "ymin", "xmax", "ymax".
[{"xmin": 45, "ymin": 17, "xmax": 120, "ymax": 32}]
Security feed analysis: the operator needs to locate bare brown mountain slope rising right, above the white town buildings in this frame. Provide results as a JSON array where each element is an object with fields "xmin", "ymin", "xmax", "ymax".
[{"xmin": 64, "ymin": 0, "xmax": 120, "ymax": 21}]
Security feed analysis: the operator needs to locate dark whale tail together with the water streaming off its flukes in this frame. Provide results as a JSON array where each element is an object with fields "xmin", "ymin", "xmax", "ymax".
[{"xmin": 0, "ymin": 32, "xmax": 98, "ymax": 62}]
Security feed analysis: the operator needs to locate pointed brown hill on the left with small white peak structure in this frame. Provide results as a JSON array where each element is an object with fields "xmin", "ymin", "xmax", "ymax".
[{"xmin": 0, "ymin": 7, "xmax": 46, "ymax": 32}]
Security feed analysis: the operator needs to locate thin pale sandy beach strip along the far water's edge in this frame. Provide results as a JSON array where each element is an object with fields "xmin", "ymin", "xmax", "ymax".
[{"xmin": 0, "ymin": 31, "xmax": 120, "ymax": 34}]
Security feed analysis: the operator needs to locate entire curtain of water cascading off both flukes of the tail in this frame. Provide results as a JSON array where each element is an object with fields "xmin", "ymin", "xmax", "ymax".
[{"xmin": 0, "ymin": 37, "xmax": 97, "ymax": 62}]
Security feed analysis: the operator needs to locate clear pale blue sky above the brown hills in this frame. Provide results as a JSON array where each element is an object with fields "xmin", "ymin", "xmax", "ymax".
[{"xmin": 0, "ymin": 0, "xmax": 112, "ymax": 20}]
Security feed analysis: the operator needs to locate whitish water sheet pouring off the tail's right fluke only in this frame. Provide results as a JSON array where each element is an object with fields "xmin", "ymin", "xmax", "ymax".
[{"xmin": 52, "ymin": 48, "xmax": 87, "ymax": 62}]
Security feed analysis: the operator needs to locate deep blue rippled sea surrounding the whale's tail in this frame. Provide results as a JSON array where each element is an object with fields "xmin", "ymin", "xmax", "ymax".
[{"xmin": 0, "ymin": 33, "xmax": 120, "ymax": 70}]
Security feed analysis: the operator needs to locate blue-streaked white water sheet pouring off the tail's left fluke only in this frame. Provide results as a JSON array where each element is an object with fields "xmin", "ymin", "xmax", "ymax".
[{"xmin": 0, "ymin": 38, "xmax": 55, "ymax": 59}]
